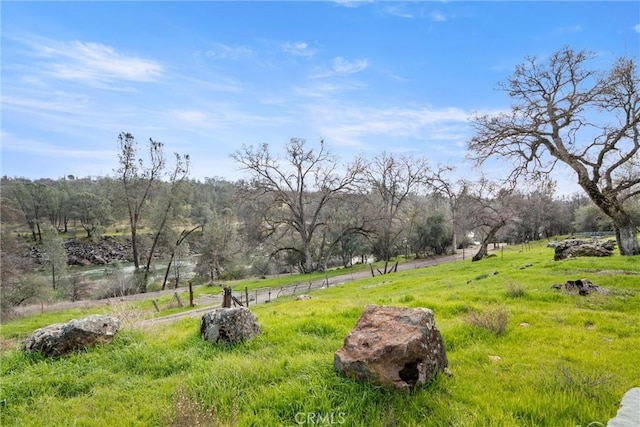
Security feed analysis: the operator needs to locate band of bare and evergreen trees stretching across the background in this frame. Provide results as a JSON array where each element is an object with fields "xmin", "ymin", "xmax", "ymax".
[{"xmin": 0, "ymin": 48, "xmax": 640, "ymax": 320}]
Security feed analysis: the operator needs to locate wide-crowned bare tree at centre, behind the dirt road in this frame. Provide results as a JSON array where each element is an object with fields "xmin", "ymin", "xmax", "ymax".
[{"xmin": 232, "ymin": 138, "xmax": 363, "ymax": 272}]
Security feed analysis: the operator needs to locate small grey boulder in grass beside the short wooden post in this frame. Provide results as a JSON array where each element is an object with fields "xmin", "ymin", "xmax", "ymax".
[{"xmin": 200, "ymin": 307, "xmax": 261, "ymax": 343}]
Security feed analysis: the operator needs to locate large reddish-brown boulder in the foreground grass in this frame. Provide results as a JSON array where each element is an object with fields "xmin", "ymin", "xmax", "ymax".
[{"xmin": 334, "ymin": 305, "xmax": 448, "ymax": 390}]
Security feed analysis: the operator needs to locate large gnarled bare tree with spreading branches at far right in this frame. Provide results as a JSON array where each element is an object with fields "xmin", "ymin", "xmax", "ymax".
[{"xmin": 469, "ymin": 47, "xmax": 640, "ymax": 255}]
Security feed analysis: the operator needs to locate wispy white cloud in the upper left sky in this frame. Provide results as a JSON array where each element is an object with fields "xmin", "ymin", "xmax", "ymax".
[{"xmin": 30, "ymin": 40, "xmax": 164, "ymax": 83}]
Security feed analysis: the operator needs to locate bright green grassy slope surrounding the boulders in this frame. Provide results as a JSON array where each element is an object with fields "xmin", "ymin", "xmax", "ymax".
[{"xmin": 0, "ymin": 242, "xmax": 640, "ymax": 427}]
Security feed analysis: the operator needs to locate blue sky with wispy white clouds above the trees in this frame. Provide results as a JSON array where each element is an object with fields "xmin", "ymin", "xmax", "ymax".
[{"xmin": 0, "ymin": 1, "xmax": 640, "ymax": 192}]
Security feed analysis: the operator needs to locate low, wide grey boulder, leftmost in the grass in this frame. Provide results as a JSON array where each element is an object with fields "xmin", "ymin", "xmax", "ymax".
[{"xmin": 22, "ymin": 315, "xmax": 120, "ymax": 357}]
